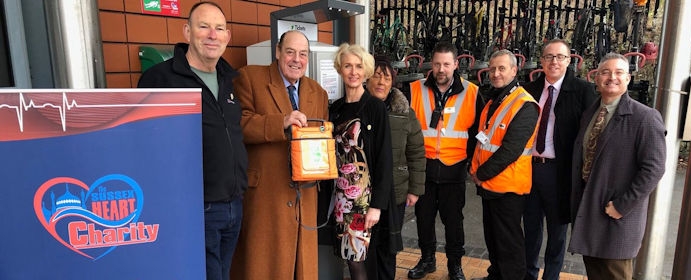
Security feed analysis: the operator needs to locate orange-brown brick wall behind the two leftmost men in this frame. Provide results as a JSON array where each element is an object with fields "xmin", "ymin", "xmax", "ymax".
[{"xmin": 98, "ymin": 0, "xmax": 333, "ymax": 88}]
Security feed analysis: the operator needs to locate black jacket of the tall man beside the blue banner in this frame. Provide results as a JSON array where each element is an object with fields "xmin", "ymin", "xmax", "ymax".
[{"xmin": 137, "ymin": 43, "xmax": 247, "ymax": 202}]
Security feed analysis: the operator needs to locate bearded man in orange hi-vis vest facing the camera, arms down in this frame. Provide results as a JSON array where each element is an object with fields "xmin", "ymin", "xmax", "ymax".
[{"xmin": 408, "ymin": 42, "xmax": 482, "ymax": 280}]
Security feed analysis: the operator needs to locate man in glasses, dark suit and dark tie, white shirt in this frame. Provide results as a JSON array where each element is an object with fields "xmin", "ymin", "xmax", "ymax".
[{"xmin": 523, "ymin": 39, "xmax": 596, "ymax": 280}]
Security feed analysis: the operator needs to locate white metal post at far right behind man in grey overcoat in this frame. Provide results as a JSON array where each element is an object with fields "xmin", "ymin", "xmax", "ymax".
[{"xmin": 633, "ymin": 0, "xmax": 691, "ymax": 280}]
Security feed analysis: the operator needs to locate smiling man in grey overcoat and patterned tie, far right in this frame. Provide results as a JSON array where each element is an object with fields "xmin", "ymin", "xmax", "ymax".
[{"xmin": 569, "ymin": 53, "xmax": 666, "ymax": 279}]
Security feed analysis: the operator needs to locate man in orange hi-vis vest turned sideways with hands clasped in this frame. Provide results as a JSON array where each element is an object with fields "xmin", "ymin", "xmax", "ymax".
[{"xmin": 470, "ymin": 50, "xmax": 539, "ymax": 280}]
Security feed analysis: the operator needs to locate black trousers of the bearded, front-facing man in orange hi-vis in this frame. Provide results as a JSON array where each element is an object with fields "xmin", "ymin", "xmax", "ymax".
[{"xmin": 415, "ymin": 179, "xmax": 466, "ymax": 259}]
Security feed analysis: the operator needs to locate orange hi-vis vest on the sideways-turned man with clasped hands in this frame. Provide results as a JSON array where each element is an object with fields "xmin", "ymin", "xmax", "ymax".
[{"xmin": 470, "ymin": 87, "xmax": 537, "ymax": 194}]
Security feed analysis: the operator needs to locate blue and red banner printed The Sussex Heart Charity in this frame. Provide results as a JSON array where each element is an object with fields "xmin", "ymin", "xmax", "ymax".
[{"xmin": 0, "ymin": 89, "xmax": 205, "ymax": 279}]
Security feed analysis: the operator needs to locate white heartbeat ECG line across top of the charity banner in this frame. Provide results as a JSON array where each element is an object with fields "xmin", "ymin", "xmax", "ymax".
[{"xmin": 0, "ymin": 92, "xmax": 197, "ymax": 132}]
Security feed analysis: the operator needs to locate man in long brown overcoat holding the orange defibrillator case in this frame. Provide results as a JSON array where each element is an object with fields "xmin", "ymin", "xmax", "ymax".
[{"xmin": 231, "ymin": 31, "xmax": 328, "ymax": 280}]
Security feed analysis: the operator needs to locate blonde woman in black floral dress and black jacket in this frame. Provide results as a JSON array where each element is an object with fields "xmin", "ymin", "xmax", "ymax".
[{"xmin": 329, "ymin": 43, "xmax": 394, "ymax": 279}]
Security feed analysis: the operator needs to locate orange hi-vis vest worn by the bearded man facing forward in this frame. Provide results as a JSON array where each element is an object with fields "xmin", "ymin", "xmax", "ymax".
[{"xmin": 410, "ymin": 78, "xmax": 478, "ymax": 166}]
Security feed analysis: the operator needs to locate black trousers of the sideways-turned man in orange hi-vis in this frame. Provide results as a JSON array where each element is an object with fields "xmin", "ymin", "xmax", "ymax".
[{"xmin": 482, "ymin": 193, "xmax": 526, "ymax": 280}]
